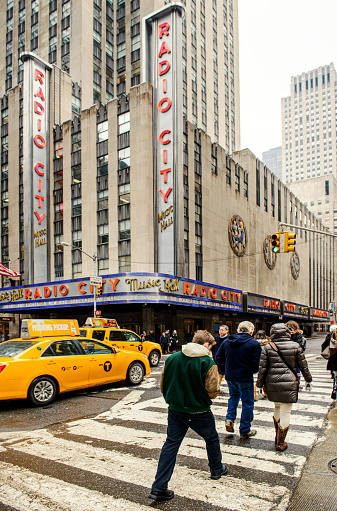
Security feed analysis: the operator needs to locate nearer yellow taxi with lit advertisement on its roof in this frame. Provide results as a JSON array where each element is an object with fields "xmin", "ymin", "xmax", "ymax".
[{"xmin": 0, "ymin": 319, "xmax": 151, "ymax": 406}]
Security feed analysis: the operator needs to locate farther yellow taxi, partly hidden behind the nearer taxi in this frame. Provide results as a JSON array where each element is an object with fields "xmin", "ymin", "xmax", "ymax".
[{"xmin": 80, "ymin": 318, "xmax": 162, "ymax": 367}]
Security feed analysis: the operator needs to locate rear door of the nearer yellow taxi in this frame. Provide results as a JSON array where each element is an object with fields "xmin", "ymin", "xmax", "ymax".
[{"xmin": 40, "ymin": 339, "xmax": 89, "ymax": 389}]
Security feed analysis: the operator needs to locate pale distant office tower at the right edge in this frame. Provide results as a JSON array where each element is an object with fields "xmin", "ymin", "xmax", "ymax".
[{"xmin": 282, "ymin": 63, "xmax": 337, "ymax": 233}]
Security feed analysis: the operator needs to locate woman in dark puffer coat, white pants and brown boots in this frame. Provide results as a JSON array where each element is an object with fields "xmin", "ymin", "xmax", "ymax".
[{"xmin": 256, "ymin": 323, "xmax": 312, "ymax": 451}]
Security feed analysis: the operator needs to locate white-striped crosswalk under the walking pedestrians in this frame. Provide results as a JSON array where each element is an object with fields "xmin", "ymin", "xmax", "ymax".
[{"xmin": 0, "ymin": 357, "xmax": 332, "ymax": 511}]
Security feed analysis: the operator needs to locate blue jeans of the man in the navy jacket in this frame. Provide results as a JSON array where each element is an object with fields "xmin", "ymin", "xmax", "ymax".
[{"xmin": 226, "ymin": 381, "xmax": 254, "ymax": 435}]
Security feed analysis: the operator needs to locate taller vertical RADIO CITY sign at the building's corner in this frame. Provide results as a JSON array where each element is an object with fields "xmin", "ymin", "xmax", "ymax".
[{"xmin": 143, "ymin": 3, "xmax": 184, "ymax": 275}]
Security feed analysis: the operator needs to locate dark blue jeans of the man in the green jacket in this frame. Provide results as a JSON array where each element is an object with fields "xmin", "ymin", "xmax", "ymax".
[{"xmin": 152, "ymin": 410, "xmax": 223, "ymax": 491}]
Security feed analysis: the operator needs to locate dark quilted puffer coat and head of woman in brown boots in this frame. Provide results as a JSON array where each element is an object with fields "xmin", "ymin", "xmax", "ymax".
[{"xmin": 256, "ymin": 323, "xmax": 312, "ymax": 403}]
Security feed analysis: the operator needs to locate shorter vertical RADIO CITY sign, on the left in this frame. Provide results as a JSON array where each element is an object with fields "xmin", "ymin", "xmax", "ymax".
[{"xmin": 21, "ymin": 53, "xmax": 51, "ymax": 283}]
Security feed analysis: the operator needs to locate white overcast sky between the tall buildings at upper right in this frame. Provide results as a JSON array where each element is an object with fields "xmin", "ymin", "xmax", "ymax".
[{"xmin": 238, "ymin": 0, "xmax": 337, "ymax": 159}]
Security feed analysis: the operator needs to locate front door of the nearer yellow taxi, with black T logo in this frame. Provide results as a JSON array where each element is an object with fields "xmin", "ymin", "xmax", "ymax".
[{"xmin": 80, "ymin": 339, "xmax": 125, "ymax": 385}]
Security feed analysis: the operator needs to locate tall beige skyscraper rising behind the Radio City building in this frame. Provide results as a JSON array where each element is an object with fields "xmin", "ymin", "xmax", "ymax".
[{"xmin": 0, "ymin": 0, "xmax": 240, "ymax": 153}]
